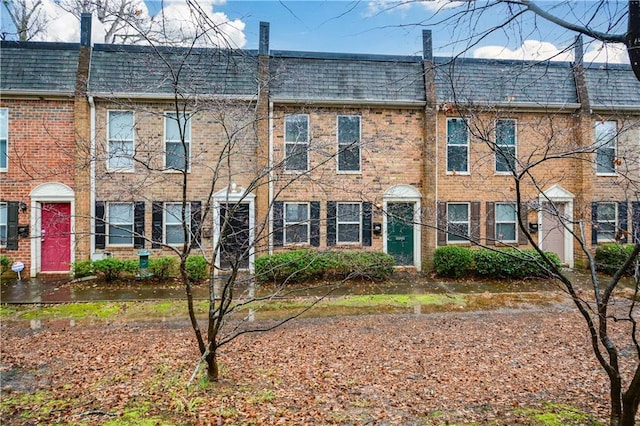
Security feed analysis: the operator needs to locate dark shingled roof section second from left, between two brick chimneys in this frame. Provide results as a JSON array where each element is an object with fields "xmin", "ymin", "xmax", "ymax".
[{"xmin": 89, "ymin": 44, "xmax": 258, "ymax": 96}]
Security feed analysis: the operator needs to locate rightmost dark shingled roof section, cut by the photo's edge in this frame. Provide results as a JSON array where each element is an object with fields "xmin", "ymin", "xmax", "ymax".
[{"xmin": 585, "ymin": 64, "xmax": 640, "ymax": 110}]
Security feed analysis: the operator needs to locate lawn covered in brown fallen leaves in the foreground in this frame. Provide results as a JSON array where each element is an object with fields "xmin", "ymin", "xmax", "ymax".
[{"xmin": 0, "ymin": 296, "xmax": 633, "ymax": 425}]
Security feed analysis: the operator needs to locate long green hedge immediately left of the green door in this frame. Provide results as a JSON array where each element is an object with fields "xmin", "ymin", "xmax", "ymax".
[{"xmin": 255, "ymin": 249, "xmax": 395, "ymax": 283}]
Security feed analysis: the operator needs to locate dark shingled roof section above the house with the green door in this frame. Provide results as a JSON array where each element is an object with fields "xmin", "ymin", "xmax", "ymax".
[{"xmin": 269, "ymin": 51, "xmax": 425, "ymax": 102}]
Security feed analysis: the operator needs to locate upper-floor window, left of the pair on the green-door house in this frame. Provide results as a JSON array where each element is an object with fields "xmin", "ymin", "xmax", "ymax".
[{"xmin": 284, "ymin": 114, "xmax": 309, "ymax": 172}]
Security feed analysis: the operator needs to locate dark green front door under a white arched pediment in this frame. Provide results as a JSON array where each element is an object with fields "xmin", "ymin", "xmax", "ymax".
[{"xmin": 387, "ymin": 203, "xmax": 413, "ymax": 266}]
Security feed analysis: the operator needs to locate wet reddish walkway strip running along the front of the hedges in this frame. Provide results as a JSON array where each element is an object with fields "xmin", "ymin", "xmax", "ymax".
[{"xmin": 0, "ymin": 272, "xmax": 568, "ymax": 304}]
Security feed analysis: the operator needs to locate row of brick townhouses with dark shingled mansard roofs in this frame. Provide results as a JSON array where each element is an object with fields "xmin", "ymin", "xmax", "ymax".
[{"xmin": 0, "ymin": 17, "xmax": 640, "ymax": 275}]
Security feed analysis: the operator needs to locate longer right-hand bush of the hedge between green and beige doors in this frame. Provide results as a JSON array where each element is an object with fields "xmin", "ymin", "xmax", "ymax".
[{"xmin": 472, "ymin": 249, "xmax": 560, "ymax": 279}]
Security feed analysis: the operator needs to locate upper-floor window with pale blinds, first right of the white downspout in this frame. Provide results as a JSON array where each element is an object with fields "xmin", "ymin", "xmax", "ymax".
[{"xmin": 108, "ymin": 111, "xmax": 134, "ymax": 170}]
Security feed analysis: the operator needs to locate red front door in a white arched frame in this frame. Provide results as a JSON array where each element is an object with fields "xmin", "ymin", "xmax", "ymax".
[{"xmin": 40, "ymin": 203, "xmax": 71, "ymax": 272}]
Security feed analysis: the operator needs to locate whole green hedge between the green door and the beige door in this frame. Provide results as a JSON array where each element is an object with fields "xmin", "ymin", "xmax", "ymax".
[{"xmin": 433, "ymin": 246, "xmax": 561, "ymax": 279}]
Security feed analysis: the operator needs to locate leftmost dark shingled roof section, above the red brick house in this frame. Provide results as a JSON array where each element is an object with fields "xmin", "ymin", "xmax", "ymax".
[{"xmin": 0, "ymin": 41, "xmax": 80, "ymax": 95}]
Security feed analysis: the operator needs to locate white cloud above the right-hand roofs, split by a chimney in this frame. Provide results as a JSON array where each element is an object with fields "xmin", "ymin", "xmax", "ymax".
[{"xmin": 473, "ymin": 40, "xmax": 629, "ymax": 64}]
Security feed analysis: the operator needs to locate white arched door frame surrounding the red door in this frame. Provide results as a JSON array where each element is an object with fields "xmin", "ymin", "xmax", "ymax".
[{"xmin": 29, "ymin": 182, "xmax": 76, "ymax": 277}]
